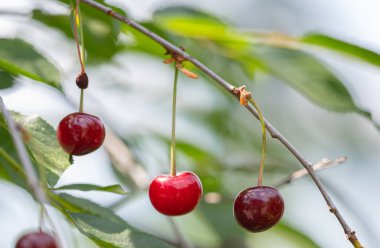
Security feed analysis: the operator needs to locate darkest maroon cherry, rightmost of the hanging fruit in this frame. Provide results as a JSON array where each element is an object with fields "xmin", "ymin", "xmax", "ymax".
[{"xmin": 234, "ymin": 186, "xmax": 284, "ymax": 232}]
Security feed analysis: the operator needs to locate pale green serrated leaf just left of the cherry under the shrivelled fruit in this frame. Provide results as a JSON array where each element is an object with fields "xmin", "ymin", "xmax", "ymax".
[{"xmin": 11, "ymin": 112, "xmax": 70, "ymax": 186}]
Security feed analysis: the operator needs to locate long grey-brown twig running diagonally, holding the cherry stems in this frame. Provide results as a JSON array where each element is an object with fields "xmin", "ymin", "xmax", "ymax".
[{"xmin": 81, "ymin": 0, "xmax": 363, "ymax": 248}]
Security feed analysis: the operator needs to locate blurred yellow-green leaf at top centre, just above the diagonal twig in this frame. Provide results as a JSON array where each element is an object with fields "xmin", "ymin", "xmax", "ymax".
[{"xmin": 153, "ymin": 7, "xmax": 257, "ymax": 81}]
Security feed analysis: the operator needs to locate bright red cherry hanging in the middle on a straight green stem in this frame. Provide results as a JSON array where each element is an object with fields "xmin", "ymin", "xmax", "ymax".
[{"xmin": 149, "ymin": 171, "xmax": 202, "ymax": 216}]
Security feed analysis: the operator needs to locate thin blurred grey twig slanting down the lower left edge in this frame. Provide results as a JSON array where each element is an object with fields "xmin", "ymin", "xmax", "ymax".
[{"xmin": 0, "ymin": 96, "xmax": 60, "ymax": 247}]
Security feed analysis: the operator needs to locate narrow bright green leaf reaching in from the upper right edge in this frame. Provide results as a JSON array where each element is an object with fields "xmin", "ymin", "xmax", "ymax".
[{"xmin": 299, "ymin": 33, "xmax": 380, "ymax": 66}]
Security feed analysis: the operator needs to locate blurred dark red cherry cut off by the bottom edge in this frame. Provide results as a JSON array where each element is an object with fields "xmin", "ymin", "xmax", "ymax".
[{"xmin": 16, "ymin": 232, "xmax": 58, "ymax": 248}]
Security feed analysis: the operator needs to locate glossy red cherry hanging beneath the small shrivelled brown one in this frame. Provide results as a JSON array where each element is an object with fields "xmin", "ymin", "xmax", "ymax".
[{"xmin": 57, "ymin": 113, "xmax": 105, "ymax": 156}]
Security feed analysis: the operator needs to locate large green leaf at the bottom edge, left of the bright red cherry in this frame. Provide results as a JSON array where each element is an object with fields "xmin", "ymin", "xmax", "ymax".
[{"xmin": 55, "ymin": 194, "xmax": 170, "ymax": 248}]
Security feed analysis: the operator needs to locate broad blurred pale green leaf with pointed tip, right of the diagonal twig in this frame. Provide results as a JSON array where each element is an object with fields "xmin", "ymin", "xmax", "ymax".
[{"xmin": 253, "ymin": 46, "xmax": 370, "ymax": 117}]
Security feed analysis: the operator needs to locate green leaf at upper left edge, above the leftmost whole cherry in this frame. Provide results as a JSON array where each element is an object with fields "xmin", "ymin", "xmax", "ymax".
[{"xmin": 0, "ymin": 38, "xmax": 61, "ymax": 89}]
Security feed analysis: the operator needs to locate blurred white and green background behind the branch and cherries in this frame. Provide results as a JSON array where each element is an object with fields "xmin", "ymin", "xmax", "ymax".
[{"xmin": 0, "ymin": 0, "xmax": 380, "ymax": 248}]
